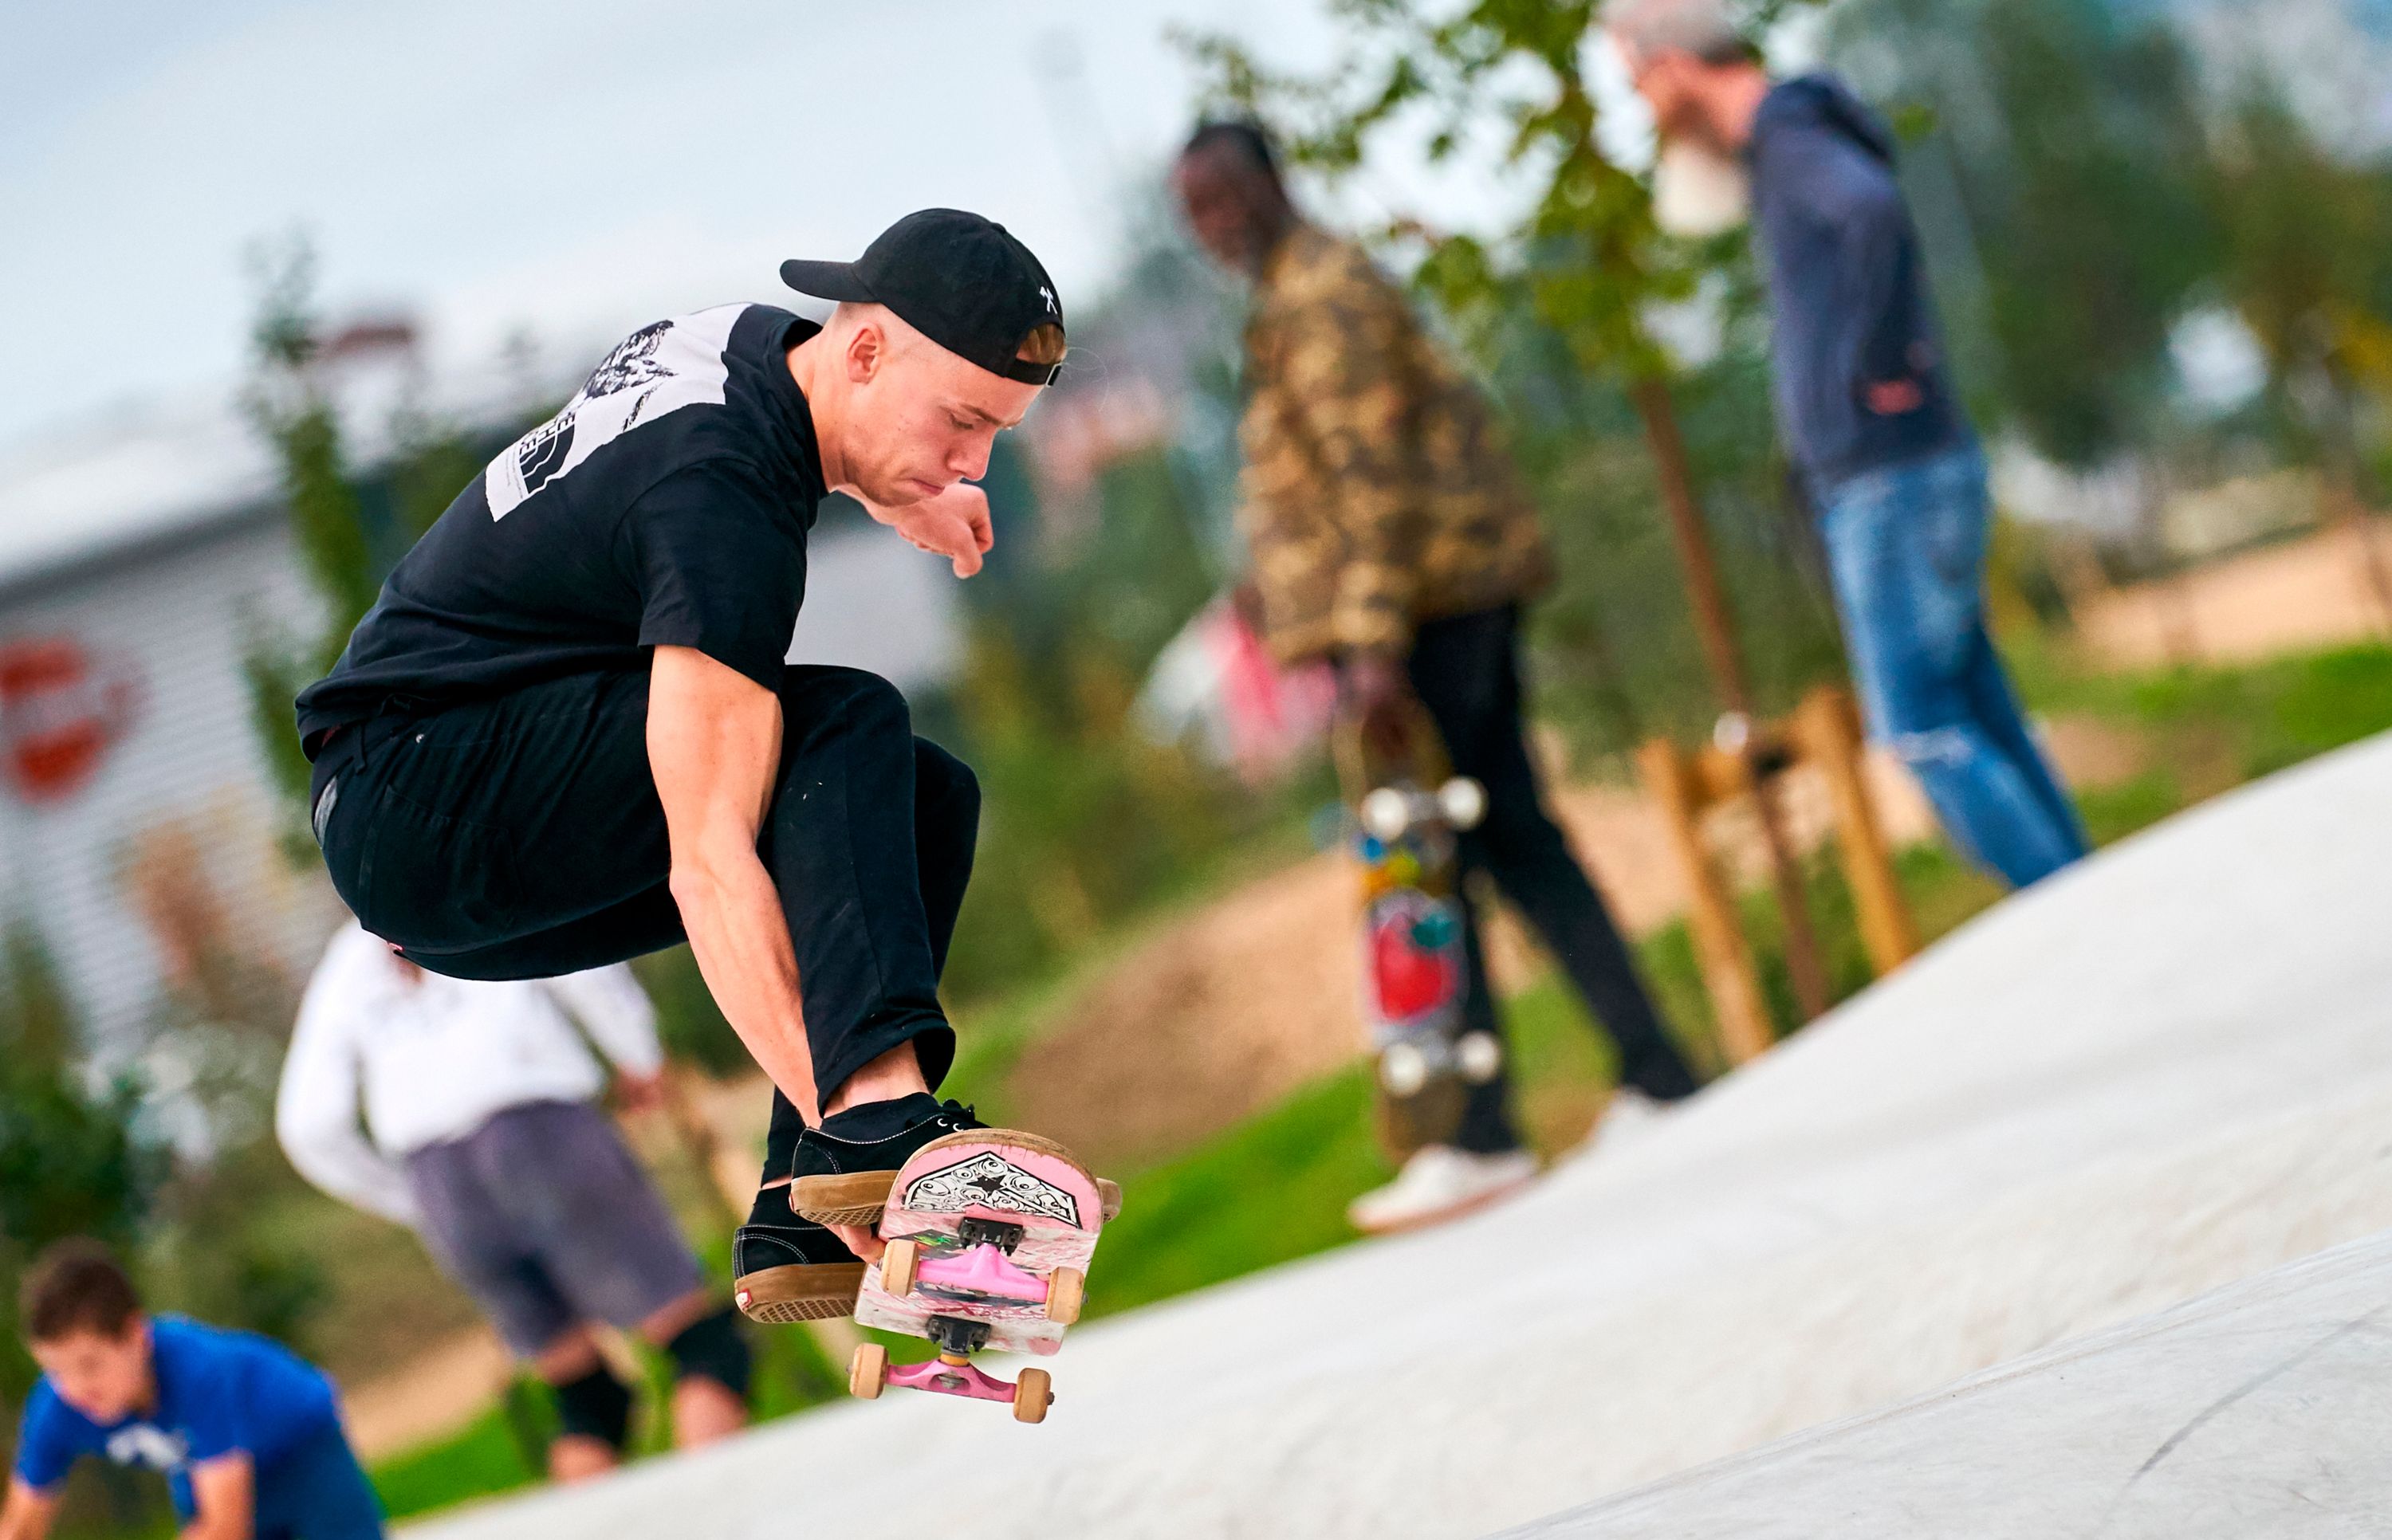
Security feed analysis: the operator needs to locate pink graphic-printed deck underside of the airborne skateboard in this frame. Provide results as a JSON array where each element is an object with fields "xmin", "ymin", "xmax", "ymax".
[{"xmin": 856, "ymin": 1129, "xmax": 1105, "ymax": 1353}]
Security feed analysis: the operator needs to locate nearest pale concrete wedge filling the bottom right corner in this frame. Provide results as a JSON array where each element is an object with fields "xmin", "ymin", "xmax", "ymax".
[{"xmin": 1505, "ymin": 1234, "xmax": 2392, "ymax": 1540}]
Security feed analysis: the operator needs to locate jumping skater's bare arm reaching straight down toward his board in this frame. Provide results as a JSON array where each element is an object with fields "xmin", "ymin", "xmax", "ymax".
[{"xmin": 648, "ymin": 648, "xmax": 820, "ymax": 1124}]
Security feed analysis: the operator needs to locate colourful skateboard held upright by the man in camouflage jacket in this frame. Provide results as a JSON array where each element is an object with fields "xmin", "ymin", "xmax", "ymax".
[{"xmin": 1337, "ymin": 710, "xmax": 1502, "ymax": 1160}]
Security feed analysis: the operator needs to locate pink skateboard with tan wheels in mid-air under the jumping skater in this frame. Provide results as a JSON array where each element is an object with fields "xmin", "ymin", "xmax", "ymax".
[{"xmin": 847, "ymin": 1129, "xmax": 1122, "ymax": 1423}]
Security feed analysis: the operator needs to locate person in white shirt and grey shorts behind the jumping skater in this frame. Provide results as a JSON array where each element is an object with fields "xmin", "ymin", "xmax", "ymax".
[{"xmin": 275, "ymin": 923, "xmax": 749, "ymax": 1480}]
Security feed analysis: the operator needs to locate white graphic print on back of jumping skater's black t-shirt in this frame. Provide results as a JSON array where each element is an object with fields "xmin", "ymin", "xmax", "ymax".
[{"xmin": 483, "ymin": 304, "xmax": 746, "ymax": 519}]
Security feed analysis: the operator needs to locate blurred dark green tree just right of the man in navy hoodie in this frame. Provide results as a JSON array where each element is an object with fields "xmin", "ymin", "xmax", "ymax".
[{"xmin": 1832, "ymin": 0, "xmax": 2220, "ymax": 466}]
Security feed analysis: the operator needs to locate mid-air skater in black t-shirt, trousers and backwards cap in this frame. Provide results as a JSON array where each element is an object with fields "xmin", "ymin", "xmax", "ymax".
[{"xmin": 299, "ymin": 208, "xmax": 1064, "ymax": 1318}]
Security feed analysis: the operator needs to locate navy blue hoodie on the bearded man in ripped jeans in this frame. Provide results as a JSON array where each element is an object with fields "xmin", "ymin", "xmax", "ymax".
[{"xmin": 1746, "ymin": 74, "xmax": 1973, "ymax": 497}]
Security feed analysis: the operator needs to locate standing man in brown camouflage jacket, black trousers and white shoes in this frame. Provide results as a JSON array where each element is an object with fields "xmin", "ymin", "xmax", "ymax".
[{"xmin": 1172, "ymin": 122, "xmax": 1696, "ymax": 1229}]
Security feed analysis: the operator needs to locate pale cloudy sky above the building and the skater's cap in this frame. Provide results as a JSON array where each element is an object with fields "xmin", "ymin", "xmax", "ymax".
[{"xmin": 0, "ymin": 0, "xmax": 1387, "ymax": 452}]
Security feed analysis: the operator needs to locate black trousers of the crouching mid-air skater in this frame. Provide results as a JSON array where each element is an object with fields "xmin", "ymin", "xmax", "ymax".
[{"xmin": 311, "ymin": 665, "xmax": 981, "ymax": 1177}]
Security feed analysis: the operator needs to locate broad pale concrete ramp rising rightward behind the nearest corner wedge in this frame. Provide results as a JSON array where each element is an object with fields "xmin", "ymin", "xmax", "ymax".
[{"xmin": 421, "ymin": 739, "xmax": 2392, "ymax": 1540}]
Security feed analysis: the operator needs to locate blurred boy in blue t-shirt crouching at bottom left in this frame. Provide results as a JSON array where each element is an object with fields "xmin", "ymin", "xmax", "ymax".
[{"xmin": 0, "ymin": 1241, "xmax": 383, "ymax": 1540}]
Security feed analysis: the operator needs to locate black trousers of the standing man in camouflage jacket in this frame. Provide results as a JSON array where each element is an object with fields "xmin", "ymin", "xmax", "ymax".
[{"xmin": 1409, "ymin": 607, "xmax": 1696, "ymax": 1150}]
